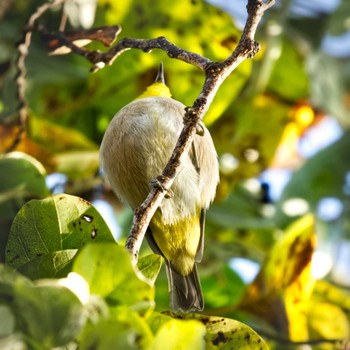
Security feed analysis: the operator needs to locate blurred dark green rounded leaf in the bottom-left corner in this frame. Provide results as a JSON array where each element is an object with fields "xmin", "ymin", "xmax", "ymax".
[{"xmin": 0, "ymin": 265, "xmax": 85, "ymax": 349}]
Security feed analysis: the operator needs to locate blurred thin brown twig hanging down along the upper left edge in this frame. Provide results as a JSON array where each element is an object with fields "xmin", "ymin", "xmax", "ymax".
[{"xmin": 6, "ymin": 0, "xmax": 65, "ymax": 152}]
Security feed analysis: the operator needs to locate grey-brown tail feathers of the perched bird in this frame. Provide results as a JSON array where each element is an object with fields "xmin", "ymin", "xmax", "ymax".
[{"xmin": 166, "ymin": 263, "xmax": 204, "ymax": 312}]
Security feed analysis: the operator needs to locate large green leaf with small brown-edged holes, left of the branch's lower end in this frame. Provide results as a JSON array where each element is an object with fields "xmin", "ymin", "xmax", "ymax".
[{"xmin": 6, "ymin": 194, "xmax": 114, "ymax": 278}]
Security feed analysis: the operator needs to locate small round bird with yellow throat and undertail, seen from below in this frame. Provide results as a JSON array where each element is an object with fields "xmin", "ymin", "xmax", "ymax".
[{"xmin": 100, "ymin": 65, "xmax": 219, "ymax": 312}]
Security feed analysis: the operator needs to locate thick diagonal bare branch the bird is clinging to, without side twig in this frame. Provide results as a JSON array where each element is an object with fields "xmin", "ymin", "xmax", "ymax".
[{"xmin": 126, "ymin": 0, "xmax": 274, "ymax": 263}]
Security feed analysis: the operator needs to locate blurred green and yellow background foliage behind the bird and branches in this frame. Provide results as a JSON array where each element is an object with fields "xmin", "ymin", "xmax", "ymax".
[{"xmin": 0, "ymin": 0, "xmax": 350, "ymax": 349}]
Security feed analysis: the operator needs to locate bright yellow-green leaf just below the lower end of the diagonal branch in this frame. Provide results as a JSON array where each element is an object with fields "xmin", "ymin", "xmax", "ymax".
[{"xmin": 73, "ymin": 243, "xmax": 154, "ymax": 313}]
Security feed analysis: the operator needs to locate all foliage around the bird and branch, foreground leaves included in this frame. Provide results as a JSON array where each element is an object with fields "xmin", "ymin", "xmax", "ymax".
[{"xmin": 0, "ymin": 0, "xmax": 350, "ymax": 349}]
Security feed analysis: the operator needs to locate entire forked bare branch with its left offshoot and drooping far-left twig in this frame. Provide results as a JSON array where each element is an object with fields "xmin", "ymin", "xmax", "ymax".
[{"xmin": 10, "ymin": 0, "xmax": 275, "ymax": 263}]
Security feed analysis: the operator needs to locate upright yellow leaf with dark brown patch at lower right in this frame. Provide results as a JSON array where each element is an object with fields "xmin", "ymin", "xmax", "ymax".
[{"xmin": 240, "ymin": 215, "xmax": 315, "ymax": 337}]
